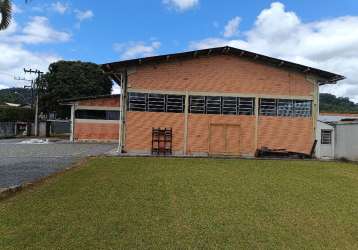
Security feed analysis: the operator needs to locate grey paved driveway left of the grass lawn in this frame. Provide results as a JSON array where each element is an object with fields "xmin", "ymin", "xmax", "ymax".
[{"xmin": 0, "ymin": 139, "xmax": 116, "ymax": 188}]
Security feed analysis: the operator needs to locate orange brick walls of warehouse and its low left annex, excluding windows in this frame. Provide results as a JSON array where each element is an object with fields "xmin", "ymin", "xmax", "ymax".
[{"xmin": 75, "ymin": 55, "xmax": 317, "ymax": 156}]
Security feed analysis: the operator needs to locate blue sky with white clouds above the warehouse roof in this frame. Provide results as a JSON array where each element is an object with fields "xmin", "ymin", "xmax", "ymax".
[{"xmin": 0, "ymin": 0, "xmax": 358, "ymax": 102}]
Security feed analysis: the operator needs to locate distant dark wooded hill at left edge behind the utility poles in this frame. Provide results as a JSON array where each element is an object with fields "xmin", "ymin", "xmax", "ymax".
[{"xmin": 0, "ymin": 88, "xmax": 32, "ymax": 104}]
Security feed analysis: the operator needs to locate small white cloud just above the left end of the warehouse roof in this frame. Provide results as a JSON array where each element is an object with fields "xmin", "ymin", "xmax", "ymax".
[{"xmin": 113, "ymin": 41, "xmax": 161, "ymax": 59}]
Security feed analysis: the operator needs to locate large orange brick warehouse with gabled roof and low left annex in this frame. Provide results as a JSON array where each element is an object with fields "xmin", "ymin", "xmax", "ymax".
[{"xmin": 63, "ymin": 47, "xmax": 344, "ymax": 156}]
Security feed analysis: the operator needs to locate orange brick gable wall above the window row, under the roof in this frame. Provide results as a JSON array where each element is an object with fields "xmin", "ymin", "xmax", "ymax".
[{"xmin": 129, "ymin": 55, "xmax": 313, "ymax": 96}]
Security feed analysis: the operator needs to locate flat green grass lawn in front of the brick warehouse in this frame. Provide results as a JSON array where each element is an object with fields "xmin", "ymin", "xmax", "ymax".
[{"xmin": 0, "ymin": 158, "xmax": 358, "ymax": 249}]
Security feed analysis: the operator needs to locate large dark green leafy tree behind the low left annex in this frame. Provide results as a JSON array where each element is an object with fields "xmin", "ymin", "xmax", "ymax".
[{"xmin": 39, "ymin": 61, "xmax": 112, "ymax": 117}]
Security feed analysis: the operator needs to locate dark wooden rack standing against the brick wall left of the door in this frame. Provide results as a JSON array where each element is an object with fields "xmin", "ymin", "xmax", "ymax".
[{"xmin": 152, "ymin": 128, "xmax": 173, "ymax": 155}]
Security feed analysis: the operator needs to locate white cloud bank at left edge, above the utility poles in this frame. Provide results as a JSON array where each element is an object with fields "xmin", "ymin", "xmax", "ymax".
[{"xmin": 0, "ymin": 17, "xmax": 70, "ymax": 88}]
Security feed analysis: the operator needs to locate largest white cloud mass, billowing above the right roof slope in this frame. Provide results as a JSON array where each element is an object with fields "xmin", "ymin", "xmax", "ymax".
[{"xmin": 190, "ymin": 2, "xmax": 358, "ymax": 101}]
